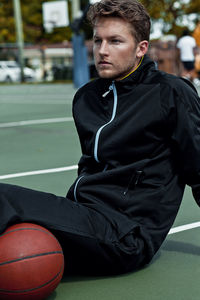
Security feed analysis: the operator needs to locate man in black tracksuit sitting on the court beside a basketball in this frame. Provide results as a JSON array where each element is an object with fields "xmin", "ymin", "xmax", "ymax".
[{"xmin": 0, "ymin": 0, "xmax": 200, "ymax": 274}]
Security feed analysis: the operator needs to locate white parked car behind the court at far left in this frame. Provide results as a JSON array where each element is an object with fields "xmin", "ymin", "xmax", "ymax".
[{"xmin": 0, "ymin": 61, "xmax": 36, "ymax": 82}]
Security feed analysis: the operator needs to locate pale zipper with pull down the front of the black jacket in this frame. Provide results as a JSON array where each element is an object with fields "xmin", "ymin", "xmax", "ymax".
[{"xmin": 94, "ymin": 81, "xmax": 118, "ymax": 163}]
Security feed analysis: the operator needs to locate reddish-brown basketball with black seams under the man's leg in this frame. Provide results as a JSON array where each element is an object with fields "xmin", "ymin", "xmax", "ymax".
[{"xmin": 0, "ymin": 223, "xmax": 64, "ymax": 300}]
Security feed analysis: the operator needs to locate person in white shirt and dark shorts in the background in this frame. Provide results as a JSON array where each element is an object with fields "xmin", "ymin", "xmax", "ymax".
[{"xmin": 177, "ymin": 29, "xmax": 200, "ymax": 85}]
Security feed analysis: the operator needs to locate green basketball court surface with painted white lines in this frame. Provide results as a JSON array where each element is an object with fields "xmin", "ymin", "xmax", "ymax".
[{"xmin": 0, "ymin": 84, "xmax": 200, "ymax": 300}]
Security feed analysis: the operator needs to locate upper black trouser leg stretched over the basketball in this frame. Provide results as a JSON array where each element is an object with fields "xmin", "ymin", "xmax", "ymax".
[{"xmin": 0, "ymin": 184, "xmax": 112, "ymax": 239}]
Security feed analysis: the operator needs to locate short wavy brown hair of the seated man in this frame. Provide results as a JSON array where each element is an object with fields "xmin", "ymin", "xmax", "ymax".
[{"xmin": 87, "ymin": 0, "xmax": 151, "ymax": 42}]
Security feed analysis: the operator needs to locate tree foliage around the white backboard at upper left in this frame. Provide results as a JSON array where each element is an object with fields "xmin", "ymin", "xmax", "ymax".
[{"xmin": 0, "ymin": 0, "xmax": 72, "ymax": 44}]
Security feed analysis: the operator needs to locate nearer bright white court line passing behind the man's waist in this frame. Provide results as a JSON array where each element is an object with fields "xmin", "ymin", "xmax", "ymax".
[{"xmin": 0, "ymin": 165, "xmax": 200, "ymax": 235}]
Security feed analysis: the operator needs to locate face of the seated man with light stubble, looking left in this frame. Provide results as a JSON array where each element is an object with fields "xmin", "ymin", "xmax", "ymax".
[{"xmin": 93, "ymin": 17, "xmax": 148, "ymax": 80}]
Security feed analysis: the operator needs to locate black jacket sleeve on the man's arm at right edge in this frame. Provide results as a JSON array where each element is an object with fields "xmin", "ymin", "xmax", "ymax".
[{"xmin": 165, "ymin": 80, "xmax": 200, "ymax": 206}]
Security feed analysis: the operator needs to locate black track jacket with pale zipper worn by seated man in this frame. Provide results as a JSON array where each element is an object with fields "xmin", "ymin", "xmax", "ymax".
[{"xmin": 67, "ymin": 56, "xmax": 200, "ymax": 261}]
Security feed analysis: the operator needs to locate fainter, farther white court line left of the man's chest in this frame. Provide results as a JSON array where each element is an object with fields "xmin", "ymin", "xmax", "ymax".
[{"xmin": 0, "ymin": 117, "xmax": 73, "ymax": 128}]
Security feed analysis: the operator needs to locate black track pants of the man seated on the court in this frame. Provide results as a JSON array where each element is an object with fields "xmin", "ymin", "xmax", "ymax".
[{"xmin": 0, "ymin": 184, "xmax": 145, "ymax": 274}]
